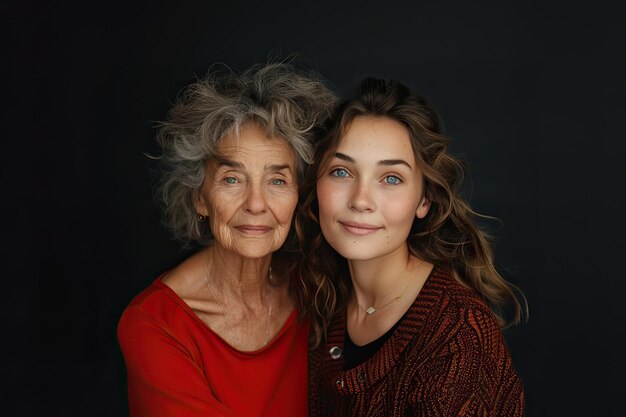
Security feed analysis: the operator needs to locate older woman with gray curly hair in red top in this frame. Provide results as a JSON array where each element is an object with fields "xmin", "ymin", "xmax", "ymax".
[{"xmin": 118, "ymin": 64, "xmax": 335, "ymax": 417}]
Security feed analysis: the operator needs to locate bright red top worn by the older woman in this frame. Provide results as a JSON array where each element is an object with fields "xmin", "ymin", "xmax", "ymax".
[{"xmin": 117, "ymin": 278, "xmax": 309, "ymax": 417}]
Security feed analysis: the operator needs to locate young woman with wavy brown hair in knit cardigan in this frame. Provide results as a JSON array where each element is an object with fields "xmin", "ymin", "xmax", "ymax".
[{"xmin": 298, "ymin": 79, "xmax": 524, "ymax": 416}]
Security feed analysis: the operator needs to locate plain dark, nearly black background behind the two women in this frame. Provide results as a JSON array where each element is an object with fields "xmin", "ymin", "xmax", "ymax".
[{"xmin": 0, "ymin": 1, "xmax": 626, "ymax": 416}]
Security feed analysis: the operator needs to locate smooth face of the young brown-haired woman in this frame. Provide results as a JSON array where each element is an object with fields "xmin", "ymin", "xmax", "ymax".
[{"xmin": 317, "ymin": 116, "xmax": 430, "ymax": 260}]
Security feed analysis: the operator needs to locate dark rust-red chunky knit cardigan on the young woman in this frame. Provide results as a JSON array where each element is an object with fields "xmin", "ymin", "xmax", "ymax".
[{"xmin": 309, "ymin": 267, "xmax": 524, "ymax": 417}]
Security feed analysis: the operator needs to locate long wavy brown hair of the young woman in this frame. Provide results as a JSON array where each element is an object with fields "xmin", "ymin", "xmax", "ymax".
[{"xmin": 296, "ymin": 78, "xmax": 525, "ymax": 346}]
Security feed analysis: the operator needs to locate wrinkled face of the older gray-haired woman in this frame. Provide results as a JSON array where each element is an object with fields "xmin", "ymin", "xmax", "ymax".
[{"xmin": 196, "ymin": 123, "xmax": 298, "ymax": 258}]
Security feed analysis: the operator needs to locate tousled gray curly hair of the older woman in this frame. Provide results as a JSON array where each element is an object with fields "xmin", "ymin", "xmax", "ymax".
[{"xmin": 156, "ymin": 63, "xmax": 336, "ymax": 245}]
